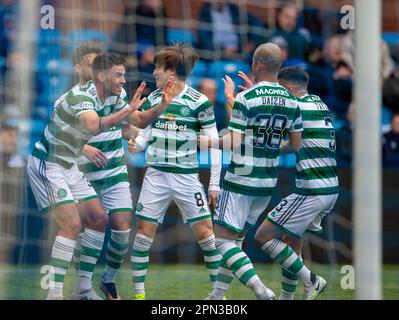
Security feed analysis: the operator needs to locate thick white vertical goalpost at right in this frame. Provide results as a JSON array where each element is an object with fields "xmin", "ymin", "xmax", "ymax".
[{"xmin": 353, "ymin": 0, "xmax": 382, "ymax": 299}]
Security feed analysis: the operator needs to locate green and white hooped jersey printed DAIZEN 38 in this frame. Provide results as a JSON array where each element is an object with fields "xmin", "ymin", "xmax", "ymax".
[{"xmin": 223, "ymin": 81, "xmax": 302, "ymax": 196}]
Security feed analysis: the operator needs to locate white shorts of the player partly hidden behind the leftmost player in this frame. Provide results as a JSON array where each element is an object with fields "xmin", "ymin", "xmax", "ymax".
[{"xmin": 97, "ymin": 181, "xmax": 133, "ymax": 214}]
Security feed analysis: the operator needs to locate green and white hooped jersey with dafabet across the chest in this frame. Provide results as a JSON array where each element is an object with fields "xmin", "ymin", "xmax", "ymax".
[{"xmin": 143, "ymin": 85, "xmax": 216, "ymax": 173}]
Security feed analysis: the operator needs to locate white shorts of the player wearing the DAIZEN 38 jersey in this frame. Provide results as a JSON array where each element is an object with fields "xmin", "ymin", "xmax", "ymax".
[{"xmin": 213, "ymin": 190, "xmax": 271, "ymax": 233}]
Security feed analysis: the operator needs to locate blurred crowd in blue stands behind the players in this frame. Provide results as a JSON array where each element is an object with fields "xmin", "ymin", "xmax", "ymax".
[{"xmin": 0, "ymin": 0, "xmax": 399, "ymax": 167}]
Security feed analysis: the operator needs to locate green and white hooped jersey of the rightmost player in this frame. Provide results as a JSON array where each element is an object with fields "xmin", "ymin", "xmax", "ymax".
[{"xmin": 295, "ymin": 94, "xmax": 339, "ymax": 195}]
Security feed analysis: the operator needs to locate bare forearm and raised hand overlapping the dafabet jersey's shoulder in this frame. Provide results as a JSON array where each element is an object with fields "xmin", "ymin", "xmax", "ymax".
[{"xmin": 129, "ymin": 78, "xmax": 176, "ymax": 129}]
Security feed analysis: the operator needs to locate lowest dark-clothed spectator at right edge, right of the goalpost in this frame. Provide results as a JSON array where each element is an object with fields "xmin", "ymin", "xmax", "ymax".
[{"xmin": 382, "ymin": 112, "xmax": 399, "ymax": 167}]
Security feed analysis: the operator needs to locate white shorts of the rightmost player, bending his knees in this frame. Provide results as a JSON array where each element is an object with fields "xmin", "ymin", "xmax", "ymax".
[{"xmin": 266, "ymin": 193, "xmax": 338, "ymax": 238}]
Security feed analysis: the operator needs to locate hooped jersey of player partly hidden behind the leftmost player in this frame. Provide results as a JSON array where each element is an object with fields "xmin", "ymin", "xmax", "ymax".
[{"xmin": 78, "ymin": 90, "xmax": 129, "ymax": 190}]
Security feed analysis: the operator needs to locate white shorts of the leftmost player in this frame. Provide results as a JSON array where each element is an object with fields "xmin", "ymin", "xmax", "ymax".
[{"xmin": 27, "ymin": 156, "xmax": 97, "ymax": 212}]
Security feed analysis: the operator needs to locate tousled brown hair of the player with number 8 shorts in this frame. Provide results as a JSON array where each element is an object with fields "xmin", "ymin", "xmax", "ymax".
[{"xmin": 154, "ymin": 43, "xmax": 199, "ymax": 81}]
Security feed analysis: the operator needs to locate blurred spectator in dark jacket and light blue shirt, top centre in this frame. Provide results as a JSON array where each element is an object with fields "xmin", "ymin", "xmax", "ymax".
[{"xmin": 197, "ymin": 0, "xmax": 265, "ymax": 59}]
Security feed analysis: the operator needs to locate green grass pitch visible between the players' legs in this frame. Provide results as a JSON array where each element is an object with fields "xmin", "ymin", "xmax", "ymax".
[{"xmin": 0, "ymin": 263, "xmax": 399, "ymax": 300}]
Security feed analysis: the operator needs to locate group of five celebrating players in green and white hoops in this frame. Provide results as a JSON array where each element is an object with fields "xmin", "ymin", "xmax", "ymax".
[{"xmin": 28, "ymin": 43, "xmax": 338, "ymax": 300}]
